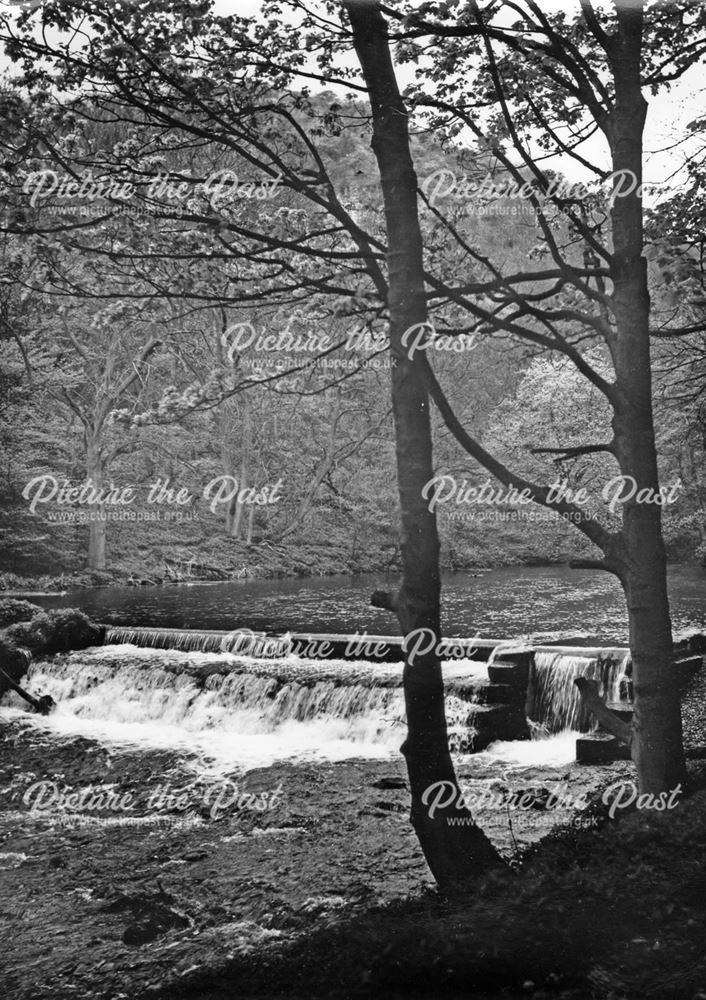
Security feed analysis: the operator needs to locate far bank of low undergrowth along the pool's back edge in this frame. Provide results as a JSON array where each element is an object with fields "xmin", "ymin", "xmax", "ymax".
[{"xmin": 0, "ymin": 490, "xmax": 600, "ymax": 590}]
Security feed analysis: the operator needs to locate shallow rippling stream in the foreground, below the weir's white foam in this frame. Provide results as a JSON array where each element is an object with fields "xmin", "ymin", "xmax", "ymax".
[{"xmin": 0, "ymin": 713, "xmax": 631, "ymax": 1000}]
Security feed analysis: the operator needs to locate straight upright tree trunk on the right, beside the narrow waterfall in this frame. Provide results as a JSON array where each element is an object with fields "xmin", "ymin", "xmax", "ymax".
[{"xmin": 609, "ymin": 4, "xmax": 685, "ymax": 794}]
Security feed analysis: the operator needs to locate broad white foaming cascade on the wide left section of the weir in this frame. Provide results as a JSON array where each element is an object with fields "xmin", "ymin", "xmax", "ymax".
[{"xmin": 6, "ymin": 646, "xmax": 490, "ymax": 768}]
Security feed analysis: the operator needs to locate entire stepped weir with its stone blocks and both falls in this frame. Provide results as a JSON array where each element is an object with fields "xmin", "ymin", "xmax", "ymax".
[{"xmin": 11, "ymin": 626, "xmax": 700, "ymax": 760}]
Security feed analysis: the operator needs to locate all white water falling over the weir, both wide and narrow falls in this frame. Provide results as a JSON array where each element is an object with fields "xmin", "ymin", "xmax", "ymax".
[{"xmin": 0, "ymin": 627, "xmax": 629, "ymax": 769}]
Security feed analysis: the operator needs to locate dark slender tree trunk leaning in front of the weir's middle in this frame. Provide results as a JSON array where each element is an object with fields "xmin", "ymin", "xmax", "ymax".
[{"xmin": 344, "ymin": 0, "xmax": 499, "ymax": 889}]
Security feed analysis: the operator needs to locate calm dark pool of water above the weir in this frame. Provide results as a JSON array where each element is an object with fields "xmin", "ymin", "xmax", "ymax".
[{"xmin": 33, "ymin": 566, "xmax": 706, "ymax": 645}]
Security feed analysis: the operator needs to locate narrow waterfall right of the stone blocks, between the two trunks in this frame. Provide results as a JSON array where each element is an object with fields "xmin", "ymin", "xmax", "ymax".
[{"xmin": 527, "ymin": 649, "xmax": 630, "ymax": 737}]
